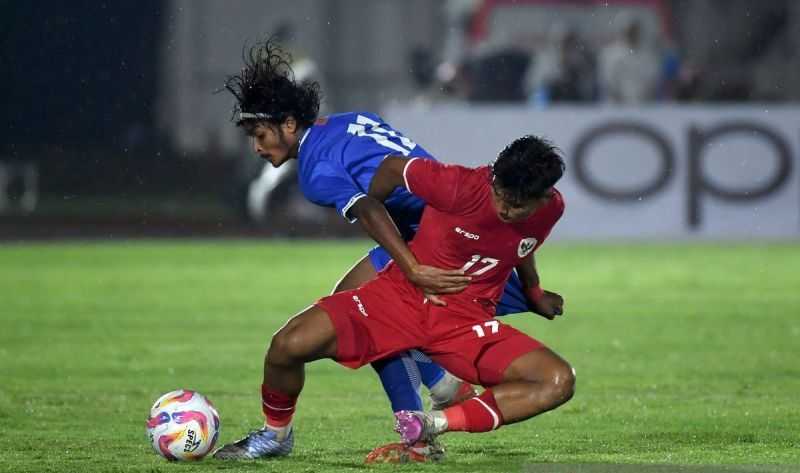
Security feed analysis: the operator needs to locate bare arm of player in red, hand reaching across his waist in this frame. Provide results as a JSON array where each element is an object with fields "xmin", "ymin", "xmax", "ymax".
[{"xmin": 351, "ymin": 156, "xmax": 470, "ymax": 305}]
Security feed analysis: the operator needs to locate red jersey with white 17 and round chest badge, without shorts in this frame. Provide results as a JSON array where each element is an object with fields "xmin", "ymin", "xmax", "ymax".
[{"xmin": 387, "ymin": 159, "xmax": 564, "ymax": 314}]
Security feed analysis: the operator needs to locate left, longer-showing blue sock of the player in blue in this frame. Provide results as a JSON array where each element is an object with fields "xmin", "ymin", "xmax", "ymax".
[{"xmin": 372, "ymin": 353, "xmax": 424, "ymax": 412}]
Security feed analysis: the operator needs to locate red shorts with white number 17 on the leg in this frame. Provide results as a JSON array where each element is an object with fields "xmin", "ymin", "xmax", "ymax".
[{"xmin": 317, "ymin": 273, "xmax": 543, "ymax": 386}]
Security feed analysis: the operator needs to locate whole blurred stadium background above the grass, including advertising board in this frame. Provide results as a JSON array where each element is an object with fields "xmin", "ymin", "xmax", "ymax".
[{"xmin": 0, "ymin": 0, "xmax": 800, "ymax": 238}]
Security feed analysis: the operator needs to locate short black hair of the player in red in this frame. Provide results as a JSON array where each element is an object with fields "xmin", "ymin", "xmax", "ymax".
[{"xmin": 492, "ymin": 135, "xmax": 565, "ymax": 205}]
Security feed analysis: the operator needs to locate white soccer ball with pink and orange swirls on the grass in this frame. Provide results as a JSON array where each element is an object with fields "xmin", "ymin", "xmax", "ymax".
[{"xmin": 147, "ymin": 389, "xmax": 219, "ymax": 461}]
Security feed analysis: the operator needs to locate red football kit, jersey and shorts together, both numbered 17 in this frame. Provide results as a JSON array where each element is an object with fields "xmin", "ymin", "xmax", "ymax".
[{"xmin": 317, "ymin": 159, "xmax": 564, "ymax": 380}]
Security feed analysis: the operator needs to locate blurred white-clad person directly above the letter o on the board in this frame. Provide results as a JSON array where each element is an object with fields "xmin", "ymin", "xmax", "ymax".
[{"xmin": 599, "ymin": 14, "xmax": 662, "ymax": 104}]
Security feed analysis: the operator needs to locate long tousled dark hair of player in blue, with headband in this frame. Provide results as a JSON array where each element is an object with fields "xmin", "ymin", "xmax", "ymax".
[{"xmin": 225, "ymin": 36, "xmax": 320, "ymax": 133}]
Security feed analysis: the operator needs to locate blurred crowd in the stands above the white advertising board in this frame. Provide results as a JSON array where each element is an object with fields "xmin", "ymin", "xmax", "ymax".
[{"xmin": 412, "ymin": 0, "xmax": 800, "ymax": 105}]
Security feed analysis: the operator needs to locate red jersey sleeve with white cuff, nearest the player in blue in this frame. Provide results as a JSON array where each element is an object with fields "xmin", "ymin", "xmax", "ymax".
[{"xmin": 403, "ymin": 158, "xmax": 465, "ymax": 212}]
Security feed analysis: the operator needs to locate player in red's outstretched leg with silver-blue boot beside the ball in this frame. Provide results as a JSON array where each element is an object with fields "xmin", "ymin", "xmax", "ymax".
[{"xmin": 214, "ymin": 306, "xmax": 336, "ymax": 460}]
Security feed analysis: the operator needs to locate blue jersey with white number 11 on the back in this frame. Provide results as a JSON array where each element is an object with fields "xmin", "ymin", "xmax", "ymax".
[{"xmin": 298, "ymin": 112, "xmax": 433, "ymax": 240}]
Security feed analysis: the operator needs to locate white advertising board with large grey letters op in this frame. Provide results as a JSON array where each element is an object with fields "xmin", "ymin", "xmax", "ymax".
[{"xmin": 383, "ymin": 105, "xmax": 800, "ymax": 240}]
